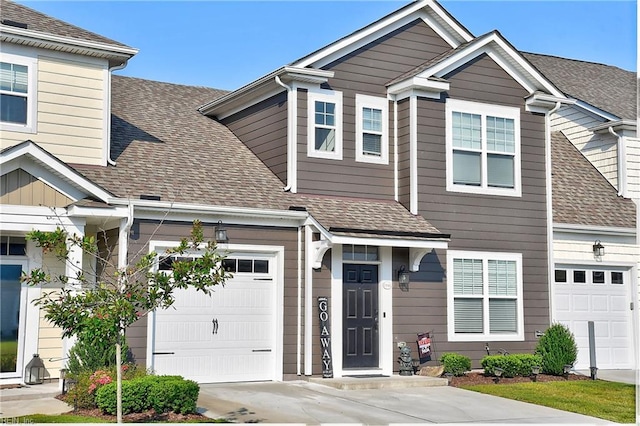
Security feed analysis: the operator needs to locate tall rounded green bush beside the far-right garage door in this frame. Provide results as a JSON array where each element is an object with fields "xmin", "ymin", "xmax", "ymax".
[{"xmin": 536, "ymin": 323, "xmax": 578, "ymax": 376}]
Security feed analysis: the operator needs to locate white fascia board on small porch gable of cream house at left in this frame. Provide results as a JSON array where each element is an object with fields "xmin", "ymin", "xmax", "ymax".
[{"xmin": 0, "ymin": 142, "xmax": 113, "ymax": 202}]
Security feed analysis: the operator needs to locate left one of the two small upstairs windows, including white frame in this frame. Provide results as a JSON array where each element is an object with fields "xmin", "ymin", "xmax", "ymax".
[{"xmin": 307, "ymin": 90, "xmax": 342, "ymax": 160}]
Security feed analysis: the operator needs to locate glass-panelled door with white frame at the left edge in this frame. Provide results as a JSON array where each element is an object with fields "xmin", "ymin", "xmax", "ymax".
[{"xmin": 0, "ymin": 261, "xmax": 26, "ymax": 378}]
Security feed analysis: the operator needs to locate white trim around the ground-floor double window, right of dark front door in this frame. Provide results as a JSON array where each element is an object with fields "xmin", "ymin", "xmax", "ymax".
[{"xmin": 447, "ymin": 250, "xmax": 524, "ymax": 342}]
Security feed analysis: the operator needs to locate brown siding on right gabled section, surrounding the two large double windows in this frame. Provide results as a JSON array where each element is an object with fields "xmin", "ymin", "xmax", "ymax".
[{"xmin": 394, "ymin": 55, "xmax": 549, "ymax": 365}]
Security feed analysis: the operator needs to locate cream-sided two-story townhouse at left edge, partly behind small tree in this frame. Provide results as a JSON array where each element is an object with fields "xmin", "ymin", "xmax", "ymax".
[{"xmin": 0, "ymin": 1, "xmax": 136, "ymax": 382}]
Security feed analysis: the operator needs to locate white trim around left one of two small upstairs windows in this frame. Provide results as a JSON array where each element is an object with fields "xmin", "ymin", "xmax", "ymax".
[{"xmin": 307, "ymin": 89, "xmax": 342, "ymax": 160}]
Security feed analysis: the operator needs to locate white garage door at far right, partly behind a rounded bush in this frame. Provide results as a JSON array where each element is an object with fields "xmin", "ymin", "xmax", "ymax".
[{"xmin": 554, "ymin": 266, "xmax": 634, "ymax": 369}]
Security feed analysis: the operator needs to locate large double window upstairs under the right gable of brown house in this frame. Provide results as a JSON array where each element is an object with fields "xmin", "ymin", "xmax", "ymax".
[{"xmin": 446, "ymin": 99, "xmax": 522, "ymax": 197}]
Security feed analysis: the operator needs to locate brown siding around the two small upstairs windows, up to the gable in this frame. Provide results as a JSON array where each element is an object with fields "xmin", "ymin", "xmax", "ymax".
[{"xmin": 298, "ymin": 20, "xmax": 450, "ymax": 199}]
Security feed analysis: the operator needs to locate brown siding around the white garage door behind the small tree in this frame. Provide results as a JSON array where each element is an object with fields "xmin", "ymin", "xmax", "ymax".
[{"xmin": 127, "ymin": 220, "xmax": 298, "ymax": 375}]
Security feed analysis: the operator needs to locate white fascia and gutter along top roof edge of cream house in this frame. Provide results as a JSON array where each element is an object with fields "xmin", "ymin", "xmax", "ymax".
[{"xmin": 0, "ymin": 25, "xmax": 138, "ymax": 59}]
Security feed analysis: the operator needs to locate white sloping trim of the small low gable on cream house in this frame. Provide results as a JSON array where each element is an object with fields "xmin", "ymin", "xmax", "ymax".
[{"xmin": 0, "ymin": 141, "xmax": 113, "ymax": 203}]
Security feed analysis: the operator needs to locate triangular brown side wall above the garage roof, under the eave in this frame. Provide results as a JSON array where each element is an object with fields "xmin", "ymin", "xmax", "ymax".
[{"xmin": 222, "ymin": 92, "xmax": 287, "ymax": 183}]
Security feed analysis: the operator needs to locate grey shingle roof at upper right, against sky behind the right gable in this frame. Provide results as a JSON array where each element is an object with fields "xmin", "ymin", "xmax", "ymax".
[{"xmin": 523, "ymin": 53, "xmax": 638, "ymax": 120}]
